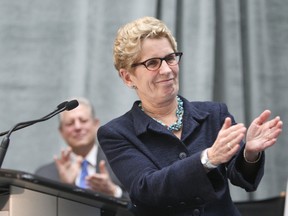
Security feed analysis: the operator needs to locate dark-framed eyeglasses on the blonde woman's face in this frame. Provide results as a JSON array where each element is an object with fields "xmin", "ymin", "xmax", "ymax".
[{"xmin": 131, "ymin": 52, "xmax": 183, "ymax": 71}]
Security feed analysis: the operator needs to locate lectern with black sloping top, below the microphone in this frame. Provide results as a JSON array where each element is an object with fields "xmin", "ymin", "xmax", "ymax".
[{"xmin": 0, "ymin": 169, "xmax": 133, "ymax": 216}]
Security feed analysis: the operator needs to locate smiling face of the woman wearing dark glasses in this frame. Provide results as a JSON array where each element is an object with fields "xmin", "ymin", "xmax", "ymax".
[{"xmin": 122, "ymin": 38, "xmax": 179, "ymax": 103}]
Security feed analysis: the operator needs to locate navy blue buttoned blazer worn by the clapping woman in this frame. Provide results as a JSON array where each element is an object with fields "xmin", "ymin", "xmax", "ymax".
[{"xmin": 97, "ymin": 97, "xmax": 264, "ymax": 216}]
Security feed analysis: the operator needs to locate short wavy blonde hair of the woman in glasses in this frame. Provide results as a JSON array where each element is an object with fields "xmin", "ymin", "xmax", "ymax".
[{"xmin": 113, "ymin": 17, "xmax": 177, "ymax": 74}]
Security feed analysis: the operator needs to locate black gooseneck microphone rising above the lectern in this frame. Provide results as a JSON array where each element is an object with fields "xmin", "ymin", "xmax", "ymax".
[{"xmin": 0, "ymin": 100, "xmax": 79, "ymax": 168}]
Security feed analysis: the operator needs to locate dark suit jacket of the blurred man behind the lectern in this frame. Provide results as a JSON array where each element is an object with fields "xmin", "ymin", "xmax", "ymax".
[{"xmin": 35, "ymin": 146, "xmax": 129, "ymax": 199}]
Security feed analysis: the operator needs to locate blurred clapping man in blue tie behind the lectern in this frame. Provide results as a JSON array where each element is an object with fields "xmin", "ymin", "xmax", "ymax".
[{"xmin": 35, "ymin": 98, "xmax": 128, "ymax": 198}]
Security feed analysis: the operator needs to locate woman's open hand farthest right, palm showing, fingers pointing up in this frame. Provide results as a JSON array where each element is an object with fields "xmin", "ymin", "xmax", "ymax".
[{"xmin": 245, "ymin": 110, "xmax": 283, "ymax": 161}]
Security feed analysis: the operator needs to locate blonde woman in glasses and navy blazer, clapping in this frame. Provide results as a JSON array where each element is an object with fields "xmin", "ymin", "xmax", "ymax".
[{"xmin": 98, "ymin": 17, "xmax": 282, "ymax": 216}]
